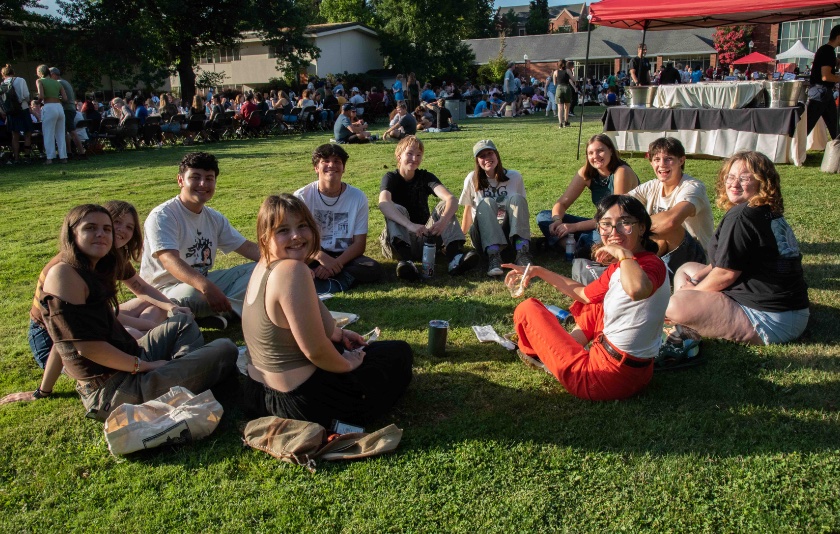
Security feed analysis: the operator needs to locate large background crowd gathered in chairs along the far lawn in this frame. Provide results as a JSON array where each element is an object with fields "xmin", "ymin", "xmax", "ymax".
[{"xmin": 0, "ymin": 61, "xmax": 632, "ymax": 164}]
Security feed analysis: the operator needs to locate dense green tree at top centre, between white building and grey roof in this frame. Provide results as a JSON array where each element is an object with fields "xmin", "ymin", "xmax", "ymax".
[{"xmin": 375, "ymin": 0, "xmax": 476, "ymax": 79}]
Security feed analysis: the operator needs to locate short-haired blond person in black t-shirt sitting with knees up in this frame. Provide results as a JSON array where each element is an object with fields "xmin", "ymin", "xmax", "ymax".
[{"xmin": 379, "ymin": 135, "xmax": 479, "ymax": 280}]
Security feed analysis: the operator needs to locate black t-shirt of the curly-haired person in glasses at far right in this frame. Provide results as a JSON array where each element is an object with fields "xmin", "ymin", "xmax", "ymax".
[{"xmin": 709, "ymin": 204, "xmax": 808, "ymax": 312}]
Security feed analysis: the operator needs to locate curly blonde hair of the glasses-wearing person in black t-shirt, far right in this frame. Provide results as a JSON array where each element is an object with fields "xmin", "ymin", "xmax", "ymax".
[{"xmin": 716, "ymin": 150, "xmax": 785, "ymax": 215}]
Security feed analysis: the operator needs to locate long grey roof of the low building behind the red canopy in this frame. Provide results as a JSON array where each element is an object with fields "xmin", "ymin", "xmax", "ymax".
[{"xmin": 464, "ymin": 27, "xmax": 717, "ymax": 65}]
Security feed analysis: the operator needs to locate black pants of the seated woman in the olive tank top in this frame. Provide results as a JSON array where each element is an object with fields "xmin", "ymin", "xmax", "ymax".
[{"xmin": 245, "ymin": 341, "xmax": 414, "ymax": 429}]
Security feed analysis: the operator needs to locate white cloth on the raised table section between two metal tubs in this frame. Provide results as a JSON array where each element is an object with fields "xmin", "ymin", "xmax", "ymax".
[{"xmin": 653, "ymin": 81, "xmax": 768, "ymax": 109}]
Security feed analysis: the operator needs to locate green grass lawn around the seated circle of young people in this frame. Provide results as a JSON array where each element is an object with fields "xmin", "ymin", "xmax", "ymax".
[{"xmin": 0, "ymin": 116, "xmax": 840, "ymax": 532}]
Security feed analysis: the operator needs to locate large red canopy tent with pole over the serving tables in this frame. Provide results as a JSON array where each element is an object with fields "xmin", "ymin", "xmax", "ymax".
[{"xmin": 578, "ymin": 0, "xmax": 840, "ymax": 158}]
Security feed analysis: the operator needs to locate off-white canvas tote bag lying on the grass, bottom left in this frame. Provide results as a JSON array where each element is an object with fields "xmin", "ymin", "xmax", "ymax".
[{"xmin": 105, "ymin": 386, "xmax": 224, "ymax": 455}]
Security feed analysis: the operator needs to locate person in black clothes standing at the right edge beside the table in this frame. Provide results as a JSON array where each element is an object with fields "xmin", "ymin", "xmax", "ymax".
[{"xmin": 808, "ymin": 26, "xmax": 840, "ymax": 138}]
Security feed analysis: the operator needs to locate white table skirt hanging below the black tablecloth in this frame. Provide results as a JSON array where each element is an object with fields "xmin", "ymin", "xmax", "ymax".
[{"xmin": 604, "ymin": 111, "xmax": 812, "ymax": 167}]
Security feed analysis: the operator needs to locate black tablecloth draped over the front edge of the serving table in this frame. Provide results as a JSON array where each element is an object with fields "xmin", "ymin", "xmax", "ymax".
[{"xmin": 601, "ymin": 105, "xmax": 805, "ymax": 137}]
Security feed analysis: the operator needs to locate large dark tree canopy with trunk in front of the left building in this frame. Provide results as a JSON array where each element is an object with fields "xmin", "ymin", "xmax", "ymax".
[{"xmin": 50, "ymin": 0, "xmax": 318, "ymax": 101}]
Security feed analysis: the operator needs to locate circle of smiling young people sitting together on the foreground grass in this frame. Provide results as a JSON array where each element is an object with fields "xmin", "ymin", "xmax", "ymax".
[{"xmin": 0, "ymin": 135, "xmax": 809, "ymax": 432}]
